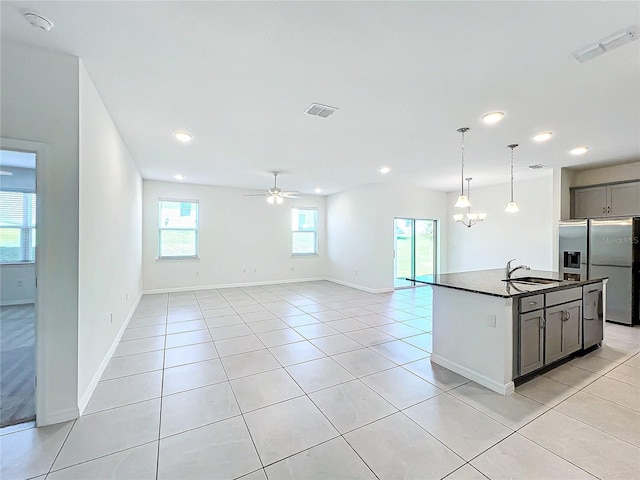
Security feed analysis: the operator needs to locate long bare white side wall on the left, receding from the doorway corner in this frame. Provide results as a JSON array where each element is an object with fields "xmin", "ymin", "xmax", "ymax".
[{"xmin": 78, "ymin": 63, "xmax": 142, "ymax": 410}]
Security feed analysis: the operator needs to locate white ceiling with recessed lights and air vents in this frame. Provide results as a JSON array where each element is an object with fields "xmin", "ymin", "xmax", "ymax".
[{"xmin": 1, "ymin": 0, "xmax": 640, "ymax": 194}]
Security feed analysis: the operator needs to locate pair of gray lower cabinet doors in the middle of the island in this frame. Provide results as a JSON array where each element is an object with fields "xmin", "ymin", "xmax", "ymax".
[{"xmin": 544, "ymin": 301, "xmax": 582, "ymax": 365}]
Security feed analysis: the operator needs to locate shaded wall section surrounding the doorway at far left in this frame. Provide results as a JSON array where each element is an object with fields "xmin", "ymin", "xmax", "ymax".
[{"xmin": 0, "ymin": 39, "xmax": 79, "ymax": 425}]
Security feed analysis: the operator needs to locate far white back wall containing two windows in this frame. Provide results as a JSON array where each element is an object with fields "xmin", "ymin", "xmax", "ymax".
[{"xmin": 142, "ymin": 180, "xmax": 327, "ymax": 291}]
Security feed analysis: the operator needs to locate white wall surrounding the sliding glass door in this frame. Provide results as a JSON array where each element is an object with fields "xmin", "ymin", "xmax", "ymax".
[{"xmin": 327, "ymin": 185, "xmax": 447, "ymax": 292}]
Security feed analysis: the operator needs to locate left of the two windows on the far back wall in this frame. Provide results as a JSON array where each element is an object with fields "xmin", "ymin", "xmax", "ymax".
[{"xmin": 158, "ymin": 200, "xmax": 198, "ymax": 258}]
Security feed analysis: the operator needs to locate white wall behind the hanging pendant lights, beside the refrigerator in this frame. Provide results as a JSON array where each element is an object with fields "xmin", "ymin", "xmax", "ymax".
[{"xmin": 447, "ymin": 171, "xmax": 557, "ymax": 272}]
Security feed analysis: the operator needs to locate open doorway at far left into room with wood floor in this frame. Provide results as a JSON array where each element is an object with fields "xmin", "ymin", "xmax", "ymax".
[{"xmin": 0, "ymin": 149, "xmax": 36, "ymax": 427}]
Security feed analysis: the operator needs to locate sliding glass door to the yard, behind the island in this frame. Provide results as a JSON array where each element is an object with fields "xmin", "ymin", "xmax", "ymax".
[{"xmin": 393, "ymin": 218, "xmax": 438, "ymax": 288}]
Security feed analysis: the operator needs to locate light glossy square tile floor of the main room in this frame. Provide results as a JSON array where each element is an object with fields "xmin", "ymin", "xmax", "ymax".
[{"xmin": 0, "ymin": 282, "xmax": 640, "ymax": 480}]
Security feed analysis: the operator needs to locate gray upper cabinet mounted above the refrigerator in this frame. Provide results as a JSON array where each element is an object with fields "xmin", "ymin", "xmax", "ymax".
[{"xmin": 571, "ymin": 181, "xmax": 640, "ymax": 218}]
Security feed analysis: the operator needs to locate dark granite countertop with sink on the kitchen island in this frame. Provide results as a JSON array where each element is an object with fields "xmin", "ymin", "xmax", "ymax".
[{"xmin": 415, "ymin": 268, "xmax": 605, "ymax": 298}]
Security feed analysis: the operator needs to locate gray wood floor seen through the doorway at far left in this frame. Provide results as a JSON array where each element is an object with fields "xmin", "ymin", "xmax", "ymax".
[{"xmin": 0, "ymin": 304, "xmax": 35, "ymax": 427}]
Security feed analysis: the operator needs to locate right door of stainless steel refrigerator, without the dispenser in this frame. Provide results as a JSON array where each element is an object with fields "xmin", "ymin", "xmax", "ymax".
[{"xmin": 588, "ymin": 217, "xmax": 640, "ymax": 325}]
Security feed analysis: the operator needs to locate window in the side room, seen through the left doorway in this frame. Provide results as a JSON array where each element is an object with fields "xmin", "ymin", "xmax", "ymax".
[{"xmin": 0, "ymin": 190, "xmax": 36, "ymax": 263}]
